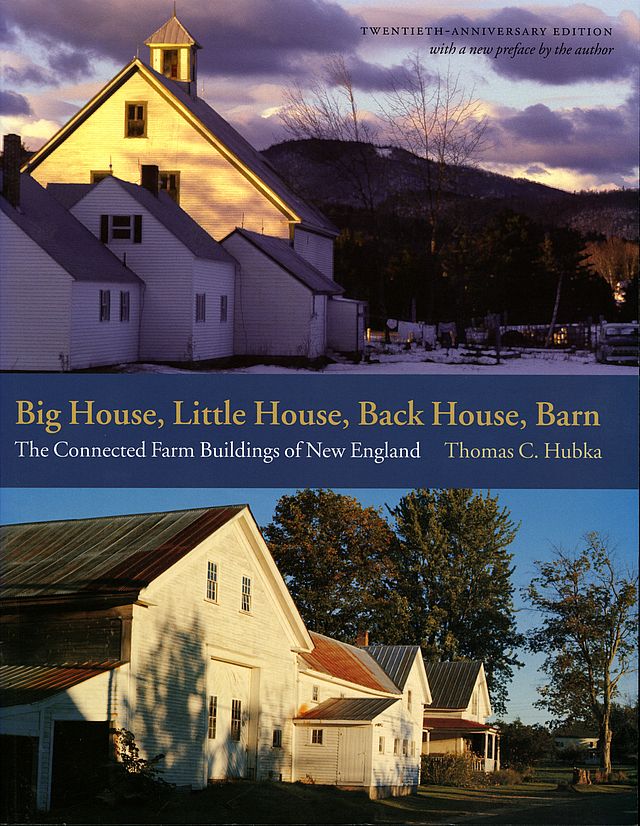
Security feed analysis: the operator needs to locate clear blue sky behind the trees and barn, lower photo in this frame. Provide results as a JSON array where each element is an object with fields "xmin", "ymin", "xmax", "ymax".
[{"xmin": 0, "ymin": 488, "xmax": 638, "ymax": 723}]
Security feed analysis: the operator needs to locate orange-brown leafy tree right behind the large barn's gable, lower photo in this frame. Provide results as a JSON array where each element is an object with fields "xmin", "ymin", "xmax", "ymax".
[{"xmin": 264, "ymin": 489, "xmax": 407, "ymax": 643}]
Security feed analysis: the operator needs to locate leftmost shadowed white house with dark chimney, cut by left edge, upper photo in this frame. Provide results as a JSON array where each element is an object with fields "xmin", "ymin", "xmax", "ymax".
[{"xmin": 0, "ymin": 135, "xmax": 143, "ymax": 371}]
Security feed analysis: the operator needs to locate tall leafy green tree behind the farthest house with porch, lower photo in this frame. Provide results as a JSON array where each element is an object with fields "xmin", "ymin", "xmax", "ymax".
[{"xmin": 391, "ymin": 489, "xmax": 523, "ymax": 714}]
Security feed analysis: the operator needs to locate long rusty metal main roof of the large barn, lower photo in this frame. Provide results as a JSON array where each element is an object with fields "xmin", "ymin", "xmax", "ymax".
[{"xmin": 0, "ymin": 505, "xmax": 246, "ymax": 601}]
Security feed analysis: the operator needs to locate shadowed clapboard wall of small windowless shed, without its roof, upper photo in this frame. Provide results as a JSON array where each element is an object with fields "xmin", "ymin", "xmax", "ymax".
[{"xmin": 223, "ymin": 234, "xmax": 325, "ymax": 358}]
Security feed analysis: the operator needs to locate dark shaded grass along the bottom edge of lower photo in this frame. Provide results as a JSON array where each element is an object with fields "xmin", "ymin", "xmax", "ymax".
[{"xmin": 46, "ymin": 781, "xmax": 637, "ymax": 826}]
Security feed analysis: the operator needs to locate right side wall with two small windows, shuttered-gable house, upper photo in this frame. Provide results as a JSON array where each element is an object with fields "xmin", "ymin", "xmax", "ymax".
[{"xmin": 192, "ymin": 259, "xmax": 236, "ymax": 361}]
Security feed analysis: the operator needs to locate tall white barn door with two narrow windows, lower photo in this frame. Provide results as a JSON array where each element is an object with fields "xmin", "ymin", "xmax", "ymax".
[{"xmin": 207, "ymin": 660, "xmax": 251, "ymax": 780}]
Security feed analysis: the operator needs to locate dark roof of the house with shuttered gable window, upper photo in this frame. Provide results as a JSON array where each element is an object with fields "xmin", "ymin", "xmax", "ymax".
[{"xmin": 47, "ymin": 175, "xmax": 235, "ymax": 264}]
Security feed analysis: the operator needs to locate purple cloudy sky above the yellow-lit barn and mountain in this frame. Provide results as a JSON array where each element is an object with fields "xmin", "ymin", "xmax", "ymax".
[{"xmin": 0, "ymin": 0, "xmax": 638, "ymax": 189}]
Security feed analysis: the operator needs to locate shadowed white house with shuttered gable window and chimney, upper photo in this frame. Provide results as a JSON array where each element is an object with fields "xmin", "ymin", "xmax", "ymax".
[{"xmin": 48, "ymin": 166, "xmax": 236, "ymax": 362}]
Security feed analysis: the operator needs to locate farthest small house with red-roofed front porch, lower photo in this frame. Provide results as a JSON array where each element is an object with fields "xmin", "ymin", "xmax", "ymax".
[{"xmin": 422, "ymin": 660, "xmax": 500, "ymax": 772}]
